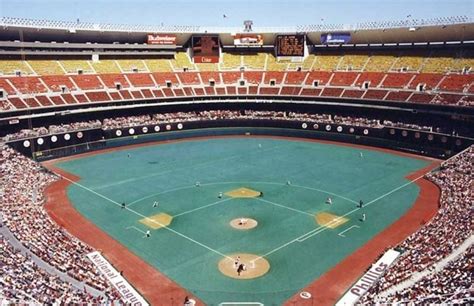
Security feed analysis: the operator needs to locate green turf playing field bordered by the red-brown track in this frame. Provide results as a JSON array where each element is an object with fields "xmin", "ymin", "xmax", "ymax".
[{"xmin": 51, "ymin": 137, "xmax": 429, "ymax": 304}]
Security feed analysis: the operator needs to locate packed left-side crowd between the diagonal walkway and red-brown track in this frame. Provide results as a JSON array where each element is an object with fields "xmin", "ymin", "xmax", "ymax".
[{"xmin": 0, "ymin": 146, "xmax": 121, "ymax": 304}]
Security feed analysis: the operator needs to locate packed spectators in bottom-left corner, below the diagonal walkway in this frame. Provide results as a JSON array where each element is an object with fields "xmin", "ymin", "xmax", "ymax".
[{"xmin": 0, "ymin": 235, "xmax": 111, "ymax": 305}]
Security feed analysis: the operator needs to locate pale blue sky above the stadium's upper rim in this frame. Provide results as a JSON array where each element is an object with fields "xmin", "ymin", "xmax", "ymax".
[{"xmin": 0, "ymin": 0, "xmax": 474, "ymax": 27}]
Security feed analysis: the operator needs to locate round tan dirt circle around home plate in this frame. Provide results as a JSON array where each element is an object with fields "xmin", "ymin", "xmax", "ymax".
[{"xmin": 218, "ymin": 253, "xmax": 270, "ymax": 279}]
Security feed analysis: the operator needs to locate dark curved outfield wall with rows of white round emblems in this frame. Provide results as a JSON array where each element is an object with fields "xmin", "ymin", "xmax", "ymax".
[{"xmin": 9, "ymin": 120, "xmax": 473, "ymax": 160}]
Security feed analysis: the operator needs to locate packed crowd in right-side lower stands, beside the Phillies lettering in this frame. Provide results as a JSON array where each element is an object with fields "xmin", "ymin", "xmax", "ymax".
[{"xmin": 363, "ymin": 146, "xmax": 474, "ymax": 303}]
